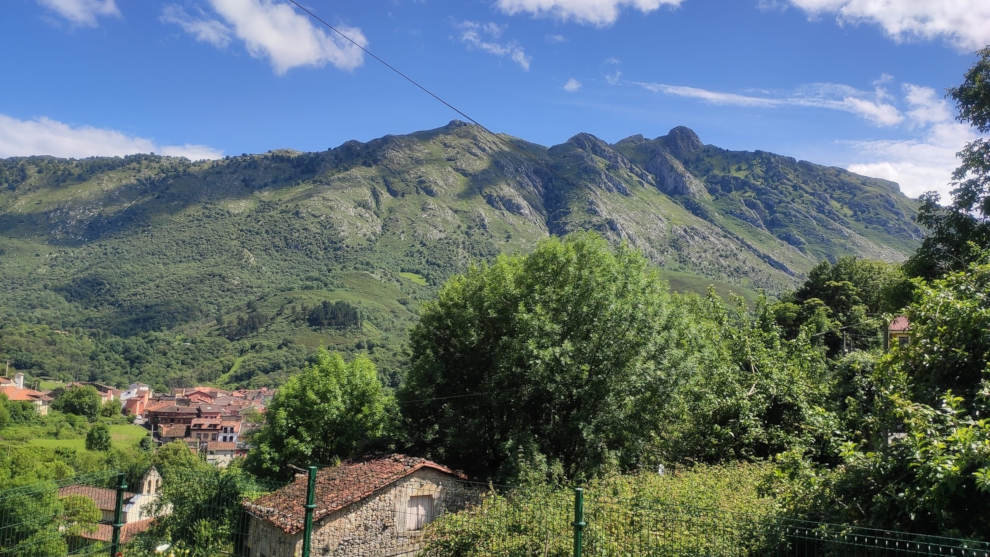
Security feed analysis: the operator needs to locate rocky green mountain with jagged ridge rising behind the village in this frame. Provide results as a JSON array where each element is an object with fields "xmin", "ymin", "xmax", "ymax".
[{"xmin": 0, "ymin": 121, "xmax": 922, "ymax": 385}]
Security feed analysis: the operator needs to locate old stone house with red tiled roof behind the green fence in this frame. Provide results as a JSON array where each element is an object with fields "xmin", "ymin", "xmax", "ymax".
[{"xmin": 243, "ymin": 454, "xmax": 479, "ymax": 557}]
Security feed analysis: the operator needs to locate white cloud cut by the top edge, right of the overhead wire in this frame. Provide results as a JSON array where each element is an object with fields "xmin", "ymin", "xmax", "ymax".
[{"xmin": 495, "ymin": 0, "xmax": 683, "ymax": 27}]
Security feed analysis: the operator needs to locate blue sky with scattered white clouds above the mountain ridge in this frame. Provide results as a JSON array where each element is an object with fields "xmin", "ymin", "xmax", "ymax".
[{"xmin": 0, "ymin": 0, "xmax": 990, "ymax": 200}]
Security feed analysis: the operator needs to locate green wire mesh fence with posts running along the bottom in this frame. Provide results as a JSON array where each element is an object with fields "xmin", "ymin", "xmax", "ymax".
[{"xmin": 0, "ymin": 469, "xmax": 990, "ymax": 557}]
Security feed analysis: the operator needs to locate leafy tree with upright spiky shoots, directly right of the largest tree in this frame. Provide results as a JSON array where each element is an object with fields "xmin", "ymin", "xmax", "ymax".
[{"xmin": 658, "ymin": 292, "xmax": 828, "ymax": 463}]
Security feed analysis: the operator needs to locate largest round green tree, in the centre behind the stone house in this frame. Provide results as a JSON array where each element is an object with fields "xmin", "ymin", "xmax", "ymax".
[{"xmin": 399, "ymin": 234, "xmax": 703, "ymax": 478}]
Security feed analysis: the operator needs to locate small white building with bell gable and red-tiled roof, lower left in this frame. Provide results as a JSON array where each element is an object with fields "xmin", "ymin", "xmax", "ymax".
[{"xmin": 58, "ymin": 467, "xmax": 162, "ymax": 542}]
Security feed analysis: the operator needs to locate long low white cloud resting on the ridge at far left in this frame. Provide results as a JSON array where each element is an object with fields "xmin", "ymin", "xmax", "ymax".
[{"xmin": 0, "ymin": 114, "xmax": 223, "ymax": 160}]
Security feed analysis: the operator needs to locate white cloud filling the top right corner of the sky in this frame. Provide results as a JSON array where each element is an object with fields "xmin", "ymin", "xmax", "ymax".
[{"xmin": 790, "ymin": 0, "xmax": 990, "ymax": 50}]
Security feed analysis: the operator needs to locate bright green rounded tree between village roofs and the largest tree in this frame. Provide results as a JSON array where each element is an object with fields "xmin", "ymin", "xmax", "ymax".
[{"xmin": 248, "ymin": 351, "xmax": 394, "ymax": 477}]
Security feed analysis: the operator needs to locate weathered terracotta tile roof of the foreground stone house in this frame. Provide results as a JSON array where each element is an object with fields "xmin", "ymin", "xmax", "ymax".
[{"xmin": 244, "ymin": 454, "xmax": 467, "ymax": 534}]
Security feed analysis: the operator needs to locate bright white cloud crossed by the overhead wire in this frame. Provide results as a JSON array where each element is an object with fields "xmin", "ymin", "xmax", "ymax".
[{"xmin": 207, "ymin": 0, "xmax": 368, "ymax": 75}]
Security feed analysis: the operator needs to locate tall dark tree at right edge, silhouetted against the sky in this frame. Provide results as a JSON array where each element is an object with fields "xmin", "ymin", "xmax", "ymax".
[{"xmin": 905, "ymin": 47, "xmax": 990, "ymax": 278}]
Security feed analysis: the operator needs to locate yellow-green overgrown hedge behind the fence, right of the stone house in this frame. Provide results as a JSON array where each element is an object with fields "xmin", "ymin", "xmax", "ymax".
[{"xmin": 424, "ymin": 464, "xmax": 779, "ymax": 557}]
